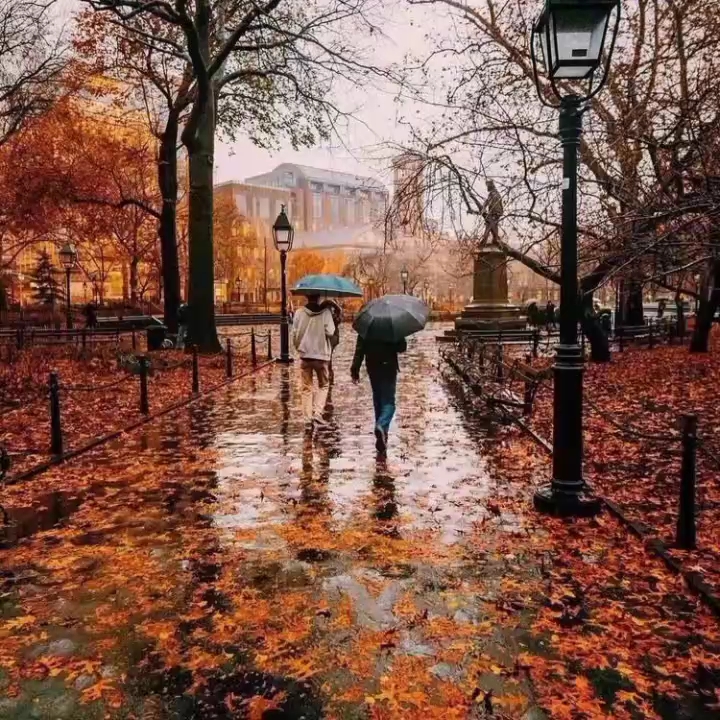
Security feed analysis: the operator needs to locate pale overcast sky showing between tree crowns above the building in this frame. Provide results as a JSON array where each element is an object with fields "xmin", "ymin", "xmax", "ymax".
[{"xmin": 59, "ymin": 0, "xmax": 437, "ymax": 188}]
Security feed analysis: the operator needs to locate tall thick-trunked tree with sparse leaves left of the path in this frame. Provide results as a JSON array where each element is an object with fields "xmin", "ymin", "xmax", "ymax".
[{"xmin": 85, "ymin": 0, "xmax": 400, "ymax": 351}]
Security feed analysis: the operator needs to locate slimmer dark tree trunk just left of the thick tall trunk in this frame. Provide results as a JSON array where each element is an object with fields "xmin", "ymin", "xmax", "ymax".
[{"xmin": 158, "ymin": 111, "xmax": 180, "ymax": 333}]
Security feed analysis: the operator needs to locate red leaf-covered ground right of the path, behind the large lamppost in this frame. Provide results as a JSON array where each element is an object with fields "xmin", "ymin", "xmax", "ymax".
[{"xmin": 516, "ymin": 329, "xmax": 720, "ymax": 595}]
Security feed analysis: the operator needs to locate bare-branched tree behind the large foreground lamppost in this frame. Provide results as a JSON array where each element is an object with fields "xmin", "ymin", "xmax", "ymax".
[{"xmin": 396, "ymin": 0, "xmax": 720, "ymax": 359}]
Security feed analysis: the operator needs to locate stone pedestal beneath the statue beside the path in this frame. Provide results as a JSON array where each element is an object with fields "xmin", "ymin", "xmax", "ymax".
[{"xmin": 455, "ymin": 245, "xmax": 527, "ymax": 330}]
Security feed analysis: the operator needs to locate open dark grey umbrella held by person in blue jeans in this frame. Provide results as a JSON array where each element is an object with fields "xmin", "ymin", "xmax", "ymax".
[{"xmin": 353, "ymin": 295, "xmax": 430, "ymax": 343}]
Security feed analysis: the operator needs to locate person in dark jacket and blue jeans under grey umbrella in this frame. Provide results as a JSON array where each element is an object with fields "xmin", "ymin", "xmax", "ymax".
[{"xmin": 350, "ymin": 335, "xmax": 407, "ymax": 455}]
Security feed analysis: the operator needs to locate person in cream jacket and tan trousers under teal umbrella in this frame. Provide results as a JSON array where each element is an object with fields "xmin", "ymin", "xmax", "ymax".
[{"xmin": 293, "ymin": 295, "xmax": 335, "ymax": 430}]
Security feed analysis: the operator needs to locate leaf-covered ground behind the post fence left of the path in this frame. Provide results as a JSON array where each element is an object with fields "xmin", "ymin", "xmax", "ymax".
[{"xmin": 0, "ymin": 335, "xmax": 264, "ymax": 472}]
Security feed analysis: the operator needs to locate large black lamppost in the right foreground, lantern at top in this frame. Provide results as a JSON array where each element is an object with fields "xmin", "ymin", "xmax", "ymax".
[{"xmin": 530, "ymin": 0, "xmax": 620, "ymax": 515}]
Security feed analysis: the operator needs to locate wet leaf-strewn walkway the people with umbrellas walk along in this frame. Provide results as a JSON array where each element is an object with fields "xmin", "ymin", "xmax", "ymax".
[{"xmin": 0, "ymin": 333, "xmax": 720, "ymax": 720}]
